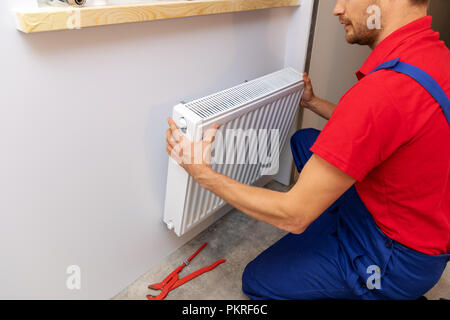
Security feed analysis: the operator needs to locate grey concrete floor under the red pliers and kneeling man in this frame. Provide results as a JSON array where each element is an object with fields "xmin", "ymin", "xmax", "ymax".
[{"xmin": 113, "ymin": 182, "xmax": 450, "ymax": 300}]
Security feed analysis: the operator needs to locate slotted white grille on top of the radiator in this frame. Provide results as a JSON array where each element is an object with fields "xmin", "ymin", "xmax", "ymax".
[{"xmin": 185, "ymin": 68, "xmax": 302, "ymax": 119}]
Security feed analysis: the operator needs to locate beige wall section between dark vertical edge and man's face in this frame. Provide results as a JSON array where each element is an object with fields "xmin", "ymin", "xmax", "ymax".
[{"xmin": 302, "ymin": 0, "xmax": 370, "ymax": 129}]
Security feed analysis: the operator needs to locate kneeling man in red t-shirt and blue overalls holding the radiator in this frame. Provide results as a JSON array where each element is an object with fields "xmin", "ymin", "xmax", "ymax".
[{"xmin": 167, "ymin": 0, "xmax": 450, "ymax": 299}]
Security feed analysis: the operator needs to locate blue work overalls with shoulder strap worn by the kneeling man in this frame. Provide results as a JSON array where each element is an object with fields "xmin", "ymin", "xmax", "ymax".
[{"xmin": 242, "ymin": 59, "xmax": 450, "ymax": 300}]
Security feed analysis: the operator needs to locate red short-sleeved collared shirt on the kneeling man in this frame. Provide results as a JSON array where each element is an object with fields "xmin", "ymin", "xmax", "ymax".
[{"xmin": 311, "ymin": 17, "xmax": 450, "ymax": 254}]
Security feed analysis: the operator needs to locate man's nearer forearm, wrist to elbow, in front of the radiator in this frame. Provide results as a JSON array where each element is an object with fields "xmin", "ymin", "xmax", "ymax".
[{"xmin": 196, "ymin": 168, "xmax": 299, "ymax": 233}]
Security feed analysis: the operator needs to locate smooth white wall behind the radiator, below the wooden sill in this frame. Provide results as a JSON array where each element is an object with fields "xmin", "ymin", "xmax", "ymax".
[{"xmin": 0, "ymin": 0, "xmax": 310, "ymax": 299}]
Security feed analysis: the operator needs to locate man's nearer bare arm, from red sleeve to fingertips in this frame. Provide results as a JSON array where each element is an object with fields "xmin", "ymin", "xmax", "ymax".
[{"xmin": 166, "ymin": 118, "xmax": 355, "ymax": 233}]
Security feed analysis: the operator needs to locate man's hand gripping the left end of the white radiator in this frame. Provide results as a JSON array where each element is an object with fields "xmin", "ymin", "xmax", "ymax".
[{"xmin": 166, "ymin": 118, "xmax": 219, "ymax": 181}]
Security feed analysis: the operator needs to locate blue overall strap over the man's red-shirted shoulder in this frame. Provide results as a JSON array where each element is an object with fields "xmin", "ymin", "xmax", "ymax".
[{"xmin": 370, "ymin": 58, "xmax": 450, "ymax": 125}]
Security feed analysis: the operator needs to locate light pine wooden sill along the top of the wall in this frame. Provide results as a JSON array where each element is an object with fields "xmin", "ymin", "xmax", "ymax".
[{"xmin": 15, "ymin": 0, "xmax": 300, "ymax": 33}]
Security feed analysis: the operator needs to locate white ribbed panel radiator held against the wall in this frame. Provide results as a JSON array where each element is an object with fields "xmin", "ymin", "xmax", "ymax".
[{"xmin": 164, "ymin": 68, "xmax": 303, "ymax": 236}]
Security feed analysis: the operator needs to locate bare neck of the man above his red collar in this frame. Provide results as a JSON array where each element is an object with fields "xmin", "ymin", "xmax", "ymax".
[{"xmin": 369, "ymin": 6, "xmax": 427, "ymax": 50}]
